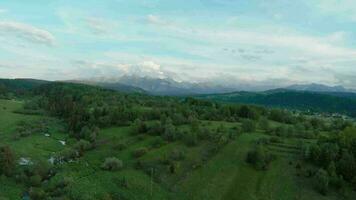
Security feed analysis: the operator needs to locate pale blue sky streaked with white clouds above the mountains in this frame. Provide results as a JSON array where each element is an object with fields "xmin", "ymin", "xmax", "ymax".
[{"xmin": 0, "ymin": 0, "xmax": 356, "ymax": 88}]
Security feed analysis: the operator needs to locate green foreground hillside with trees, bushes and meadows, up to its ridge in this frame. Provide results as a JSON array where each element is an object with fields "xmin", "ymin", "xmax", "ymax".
[{"xmin": 0, "ymin": 82, "xmax": 356, "ymax": 200}]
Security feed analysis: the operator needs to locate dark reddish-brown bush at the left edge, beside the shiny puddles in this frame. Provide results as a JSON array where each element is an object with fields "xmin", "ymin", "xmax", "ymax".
[{"xmin": 0, "ymin": 146, "xmax": 15, "ymax": 176}]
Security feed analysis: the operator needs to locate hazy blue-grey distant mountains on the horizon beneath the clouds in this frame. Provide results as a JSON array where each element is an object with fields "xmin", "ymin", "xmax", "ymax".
[{"xmin": 77, "ymin": 76, "xmax": 356, "ymax": 96}]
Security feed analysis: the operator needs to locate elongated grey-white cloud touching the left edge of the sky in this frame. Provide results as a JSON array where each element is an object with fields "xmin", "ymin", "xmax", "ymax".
[{"xmin": 0, "ymin": 21, "xmax": 55, "ymax": 46}]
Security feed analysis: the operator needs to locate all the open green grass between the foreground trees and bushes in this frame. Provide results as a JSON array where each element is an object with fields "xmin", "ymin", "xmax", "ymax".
[{"xmin": 0, "ymin": 100, "xmax": 352, "ymax": 200}]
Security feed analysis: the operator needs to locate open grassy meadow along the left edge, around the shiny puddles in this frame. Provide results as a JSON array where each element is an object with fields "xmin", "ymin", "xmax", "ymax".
[{"xmin": 0, "ymin": 99, "xmax": 66, "ymax": 199}]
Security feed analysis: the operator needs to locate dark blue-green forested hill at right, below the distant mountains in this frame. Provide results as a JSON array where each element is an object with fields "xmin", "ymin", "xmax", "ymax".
[{"xmin": 198, "ymin": 89, "xmax": 356, "ymax": 117}]
